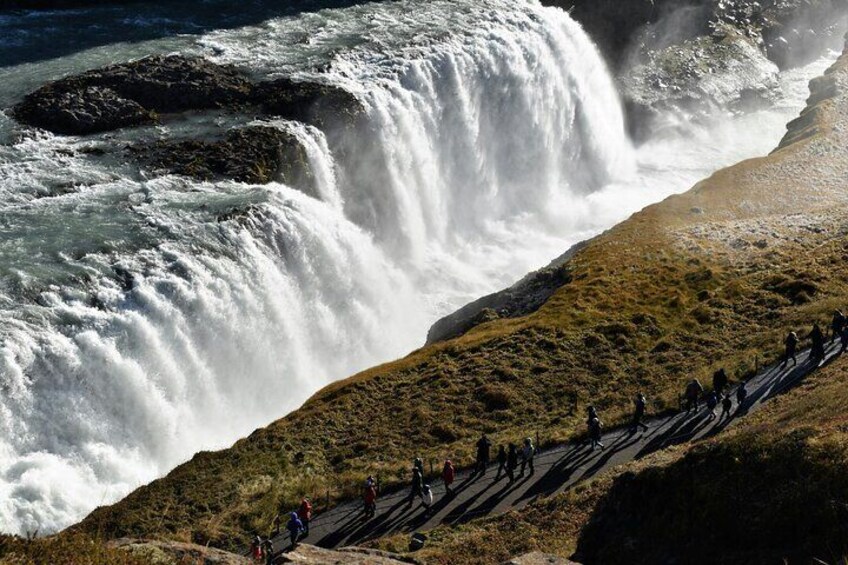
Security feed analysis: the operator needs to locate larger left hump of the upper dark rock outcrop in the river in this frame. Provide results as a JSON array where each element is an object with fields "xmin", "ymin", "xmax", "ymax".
[{"xmin": 13, "ymin": 55, "xmax": 252, "ymax": 135}]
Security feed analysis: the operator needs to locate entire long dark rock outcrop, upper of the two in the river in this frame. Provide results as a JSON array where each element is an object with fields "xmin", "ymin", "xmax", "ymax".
[{"xmin": 13, "ymin": 55, "xmax": 365, "ymax": 135}]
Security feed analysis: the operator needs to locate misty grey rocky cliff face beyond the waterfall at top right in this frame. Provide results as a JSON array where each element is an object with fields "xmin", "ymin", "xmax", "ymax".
[{"xmin": 548, "ymin": 0, "xmax": 848, "ymax": 136}]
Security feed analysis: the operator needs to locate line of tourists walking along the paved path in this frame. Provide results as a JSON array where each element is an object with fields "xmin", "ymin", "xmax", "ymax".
[{"xmin": 251, "ymin": 316, "xmax": 848, "ymax": 563}]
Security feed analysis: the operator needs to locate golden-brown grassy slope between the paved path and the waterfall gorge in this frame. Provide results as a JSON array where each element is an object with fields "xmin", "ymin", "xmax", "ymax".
[{"xmin": 74, "ymin": 39, "xmax": 848, "ymax": 547}]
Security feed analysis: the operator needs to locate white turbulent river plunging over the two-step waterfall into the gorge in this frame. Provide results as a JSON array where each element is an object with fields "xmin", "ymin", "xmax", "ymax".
[{"xmin": 0, "ymin": 0, "xmax": 840, "ymax": 532}]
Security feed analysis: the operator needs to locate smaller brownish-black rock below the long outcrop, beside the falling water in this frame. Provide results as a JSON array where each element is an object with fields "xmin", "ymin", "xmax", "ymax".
[{"xmin": 137, "ymin": 126, "xmax": 315, "ymax": 189}]
